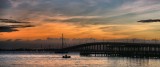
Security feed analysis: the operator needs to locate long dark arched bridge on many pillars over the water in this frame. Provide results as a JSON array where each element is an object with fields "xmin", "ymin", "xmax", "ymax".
[{"xmin": 62, "ymin": 42, "xmax": 160, "ymax": 58}]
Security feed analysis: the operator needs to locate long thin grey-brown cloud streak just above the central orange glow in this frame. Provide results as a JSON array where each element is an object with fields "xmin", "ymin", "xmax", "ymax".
[{"xmin": 43, "ymin": 16, "xmax": 114, "ymax": 25}]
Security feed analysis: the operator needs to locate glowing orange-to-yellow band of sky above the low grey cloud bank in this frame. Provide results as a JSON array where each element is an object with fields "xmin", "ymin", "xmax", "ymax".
[{"xmin": 0, "ymin": 22, "xmax": 160, "ymax": 40}]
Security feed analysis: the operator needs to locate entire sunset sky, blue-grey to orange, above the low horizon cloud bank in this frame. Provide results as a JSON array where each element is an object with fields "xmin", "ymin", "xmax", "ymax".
[{"xmin": 0, "ymin": 0, "xmax": 160, "ymax": 40}]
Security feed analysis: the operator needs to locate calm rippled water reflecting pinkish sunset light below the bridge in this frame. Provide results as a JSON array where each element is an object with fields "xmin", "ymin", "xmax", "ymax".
[{"xmin": 0, "ymin": 52, "xmax": 160, "ymax": 67}]
